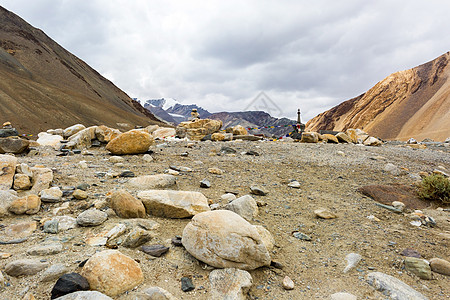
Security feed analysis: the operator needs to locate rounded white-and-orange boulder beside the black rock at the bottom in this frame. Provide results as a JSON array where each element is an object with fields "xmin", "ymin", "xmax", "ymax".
[{"xmin": 80, "ymin": 250, "xmax": 144, "ymax": 297}]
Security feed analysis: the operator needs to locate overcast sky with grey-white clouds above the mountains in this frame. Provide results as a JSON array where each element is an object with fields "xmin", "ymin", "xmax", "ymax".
[{"xmin": 0, "ymin": 0, "xmax": 450, "ymax": 121}]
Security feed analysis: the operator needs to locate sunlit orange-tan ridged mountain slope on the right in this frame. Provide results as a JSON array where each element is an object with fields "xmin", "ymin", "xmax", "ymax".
[{"xmin": 306, "ymin": 52, "xmax": 450, "ymax": 141}]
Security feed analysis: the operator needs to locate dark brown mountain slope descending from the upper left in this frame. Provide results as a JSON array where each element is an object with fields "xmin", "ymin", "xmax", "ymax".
[{"xmin": 0, "ymin": 6, "xmax": 159, "ymax": 134}]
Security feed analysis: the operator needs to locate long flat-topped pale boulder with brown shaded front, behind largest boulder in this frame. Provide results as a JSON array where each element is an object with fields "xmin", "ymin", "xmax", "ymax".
[{"xmin": 137, "ymin": 190, "xmax": 210, "ymax": 218}]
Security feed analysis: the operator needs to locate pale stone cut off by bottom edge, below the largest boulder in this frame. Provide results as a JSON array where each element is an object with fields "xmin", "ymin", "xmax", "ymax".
[{"xmin": 209, "ymin": 268, "xmax": 253, "ymax": 300}]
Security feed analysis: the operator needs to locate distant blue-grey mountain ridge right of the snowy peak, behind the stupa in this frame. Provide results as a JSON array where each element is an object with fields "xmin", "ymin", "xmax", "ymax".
[{"xmin": 209, "ymin": 111, "xmax": 295, "ymax": 138}]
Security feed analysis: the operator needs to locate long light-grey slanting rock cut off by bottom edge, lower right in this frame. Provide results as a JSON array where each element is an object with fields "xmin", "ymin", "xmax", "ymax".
[{"xmin": 367, "ymin": 272, "xmax": 428, "ymax": 300}]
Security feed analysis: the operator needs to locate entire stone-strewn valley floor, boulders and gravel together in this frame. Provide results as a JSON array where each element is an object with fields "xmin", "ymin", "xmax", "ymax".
[{"xmin": 0, "ymin": 122, "xmax": 450, "ymax": 299}]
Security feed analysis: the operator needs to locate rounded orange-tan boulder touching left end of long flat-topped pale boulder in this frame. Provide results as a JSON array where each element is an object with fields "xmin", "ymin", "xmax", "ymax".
[{"xmin": 111, "ymin": 189, "xmax": 145, "ymax": 218}]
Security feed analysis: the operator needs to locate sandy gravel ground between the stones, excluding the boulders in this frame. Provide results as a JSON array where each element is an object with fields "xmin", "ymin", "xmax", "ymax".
[{"xmin": 0, "ymin": 141, "xmax": 450, "ymax": 299}]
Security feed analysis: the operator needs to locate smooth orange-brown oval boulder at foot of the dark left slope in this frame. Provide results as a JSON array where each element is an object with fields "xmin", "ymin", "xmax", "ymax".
[{"xmin": 106, "ymin": 129, "xmax": 154, "ymax": 155}]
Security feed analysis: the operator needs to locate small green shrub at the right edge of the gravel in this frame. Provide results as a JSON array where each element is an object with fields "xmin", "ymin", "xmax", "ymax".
[{"xmin": 417, "ymin": 174, "xmax": 450, "ymax": 204}]
